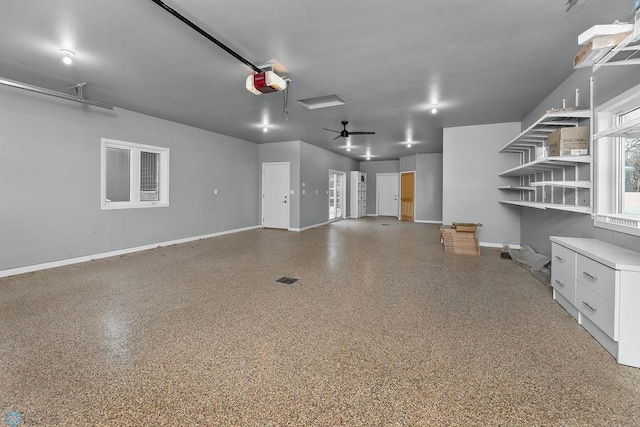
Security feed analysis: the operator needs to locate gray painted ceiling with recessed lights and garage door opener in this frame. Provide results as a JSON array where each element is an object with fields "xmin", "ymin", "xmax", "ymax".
[{"xmin": 0, "ymin": 0, "xmax": 633, "ymax": 160}]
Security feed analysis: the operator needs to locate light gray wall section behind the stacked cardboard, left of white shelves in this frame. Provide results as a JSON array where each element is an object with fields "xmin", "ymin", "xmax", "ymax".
[{"xmin": 442, "ymin": 122, "xmax": 520, "ymax": 244}]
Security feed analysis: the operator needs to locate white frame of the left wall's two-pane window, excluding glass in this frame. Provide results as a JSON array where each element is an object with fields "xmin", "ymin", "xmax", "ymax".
[{"xmin": 100, "ymin": 138, "xmax": 169, "ymax": 210}]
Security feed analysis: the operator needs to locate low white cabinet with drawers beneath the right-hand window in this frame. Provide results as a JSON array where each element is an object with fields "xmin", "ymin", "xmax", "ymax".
[{"xmin": 551, "ymin": 236, "xmax": 640, "ymax": 367}]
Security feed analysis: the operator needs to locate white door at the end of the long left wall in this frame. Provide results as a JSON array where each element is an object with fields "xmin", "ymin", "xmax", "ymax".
[{"xmin": 262, "ymin": 163, "xmax": 291, "ymax": 229}]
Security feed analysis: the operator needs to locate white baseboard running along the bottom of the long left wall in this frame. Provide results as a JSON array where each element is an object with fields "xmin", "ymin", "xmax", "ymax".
[{"xmin": 0, "ymin": 225, "xmax": 260, "ymax": 277}]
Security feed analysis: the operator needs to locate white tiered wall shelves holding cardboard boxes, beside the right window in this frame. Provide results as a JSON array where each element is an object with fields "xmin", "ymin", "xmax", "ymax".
[{"xmin": 498, "ymin": 110, "xmax": 591, "ymax": 214}]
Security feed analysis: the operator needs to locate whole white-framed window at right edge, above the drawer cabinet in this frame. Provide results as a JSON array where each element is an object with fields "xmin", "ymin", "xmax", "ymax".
[{"xmin": 594, "ymin": 86, "xmax": 640, "ymax": 235}]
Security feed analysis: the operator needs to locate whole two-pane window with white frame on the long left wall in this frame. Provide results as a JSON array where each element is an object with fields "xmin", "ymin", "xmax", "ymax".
[{"xmin": 101, "ymin": 138, "xmax": 169, "ymax": 209}]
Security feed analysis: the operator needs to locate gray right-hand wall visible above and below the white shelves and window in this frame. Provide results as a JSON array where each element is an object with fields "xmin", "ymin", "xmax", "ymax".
[{"xmin": 521, "ymin": 66, "xmax": 640, "ymax": 255}]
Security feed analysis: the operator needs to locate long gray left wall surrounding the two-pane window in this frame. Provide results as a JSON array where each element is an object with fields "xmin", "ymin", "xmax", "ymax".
[{"xmin": 0, "ymin": 87, "xmax": 258, "ymax": 270}]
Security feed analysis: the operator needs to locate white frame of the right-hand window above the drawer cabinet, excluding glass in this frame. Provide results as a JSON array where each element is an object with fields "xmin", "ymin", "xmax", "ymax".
[{"xmin": 592, "ymin": 85, "xmax": 640, "ymax": 236}]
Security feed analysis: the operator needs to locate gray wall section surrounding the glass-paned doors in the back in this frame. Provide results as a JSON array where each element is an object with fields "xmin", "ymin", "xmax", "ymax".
[{"xmin": 300, "ymin": 142, "xmax": 359, "ymax": 228}]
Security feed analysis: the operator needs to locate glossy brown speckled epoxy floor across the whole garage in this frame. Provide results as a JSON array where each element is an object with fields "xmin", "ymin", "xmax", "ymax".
[{"xmin": 0, "ymin": 218, "xmax": 640, "ymax": 426}]
